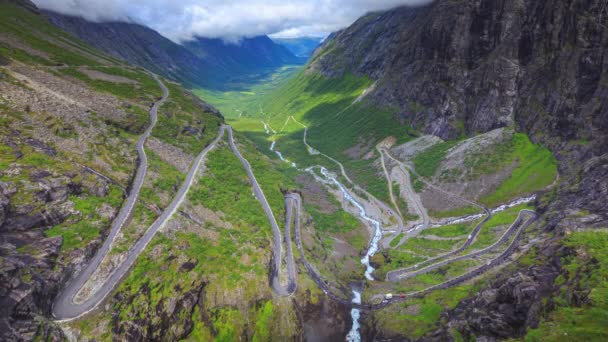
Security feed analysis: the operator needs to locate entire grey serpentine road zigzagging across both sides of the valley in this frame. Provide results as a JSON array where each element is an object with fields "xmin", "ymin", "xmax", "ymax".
[{"xmin": 52, "ymin": 75, "xmax": 537, "ymax": 321}]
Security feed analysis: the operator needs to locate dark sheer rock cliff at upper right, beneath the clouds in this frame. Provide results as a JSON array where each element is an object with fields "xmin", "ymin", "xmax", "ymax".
[{"xmin": 309, "ymin": 0, "xmax": 608, "ymax": 144}]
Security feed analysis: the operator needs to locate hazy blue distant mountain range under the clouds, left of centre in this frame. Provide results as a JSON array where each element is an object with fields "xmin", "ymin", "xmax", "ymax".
[{"xmin": 43, "ymin": 11, "xmax": 306, "ymax": 88}]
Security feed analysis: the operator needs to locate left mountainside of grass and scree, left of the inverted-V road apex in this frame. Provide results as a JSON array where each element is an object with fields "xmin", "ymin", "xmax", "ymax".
[{"xmin": 0, "ymin": 1, "xmax": 230, "ymax": 341}]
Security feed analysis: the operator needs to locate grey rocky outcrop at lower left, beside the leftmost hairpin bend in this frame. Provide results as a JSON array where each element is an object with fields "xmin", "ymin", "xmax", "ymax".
[{"xmin": 0, "ymin": 170, "xmax": 107, "ymax": 341}]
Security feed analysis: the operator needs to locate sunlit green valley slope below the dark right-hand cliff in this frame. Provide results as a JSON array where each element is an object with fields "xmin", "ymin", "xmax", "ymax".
[{"xmin": 199, "ymin": 72, "xmax": 409, "ymax": 200}]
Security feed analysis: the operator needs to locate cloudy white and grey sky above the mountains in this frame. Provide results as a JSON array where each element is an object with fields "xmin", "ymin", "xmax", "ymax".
[{"xmin": 33, "ymin": 0, "xmax": 430, "ymax": 41}]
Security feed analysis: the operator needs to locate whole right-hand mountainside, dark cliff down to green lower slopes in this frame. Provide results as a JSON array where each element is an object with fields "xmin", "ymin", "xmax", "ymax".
[{"xmin": 208, "ymin": 0, "xmax": 608, "ymax": 341}]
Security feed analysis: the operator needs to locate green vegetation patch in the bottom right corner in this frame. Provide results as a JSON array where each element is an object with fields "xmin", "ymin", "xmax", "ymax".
[{"xmin": 524, "ymin": 231, "xmax": 608, "ymax": 342}]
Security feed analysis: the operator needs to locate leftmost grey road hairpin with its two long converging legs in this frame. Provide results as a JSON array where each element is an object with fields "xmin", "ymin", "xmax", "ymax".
[{"xmin": 52, "ymin": 76, "xmax": 224, "ymax": 321}]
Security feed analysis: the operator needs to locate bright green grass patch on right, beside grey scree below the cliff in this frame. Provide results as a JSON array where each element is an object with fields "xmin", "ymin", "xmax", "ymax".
[{"xmin": 481, "ymin": 133, "xmax": 557, "ymax": 206}]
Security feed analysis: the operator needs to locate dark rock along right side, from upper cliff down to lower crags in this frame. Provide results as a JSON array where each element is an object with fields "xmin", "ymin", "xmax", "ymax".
[{"xmin": 308, "ymin": 0, "xmax": 608, "ymax": 340}]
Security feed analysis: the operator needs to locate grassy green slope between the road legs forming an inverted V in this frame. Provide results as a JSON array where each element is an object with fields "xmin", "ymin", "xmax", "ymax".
[{"xmin": 77, "ymin": 136, "xmax": 302, "ymax": 341}]
